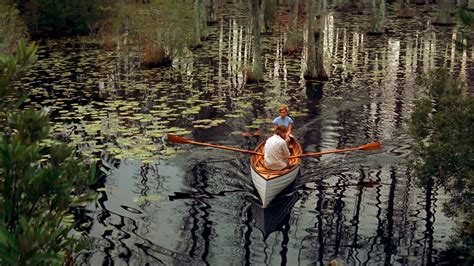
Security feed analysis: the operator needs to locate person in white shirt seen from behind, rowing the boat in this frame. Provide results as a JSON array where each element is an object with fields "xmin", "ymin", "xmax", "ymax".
[{"xmin": 263, "ymin": 125, "xmax": 290, "ymax": 170}]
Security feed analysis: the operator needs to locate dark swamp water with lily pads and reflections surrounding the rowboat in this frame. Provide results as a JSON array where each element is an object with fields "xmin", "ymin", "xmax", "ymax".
[{"xmin": 20, "ymin": 4, "xmax": 474, "ymax": 265}]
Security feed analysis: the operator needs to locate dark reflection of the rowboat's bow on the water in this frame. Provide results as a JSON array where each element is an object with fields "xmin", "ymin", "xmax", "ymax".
[{"xmin": 250, "ymin": 187, "xmax": 300, "ymax": 240}]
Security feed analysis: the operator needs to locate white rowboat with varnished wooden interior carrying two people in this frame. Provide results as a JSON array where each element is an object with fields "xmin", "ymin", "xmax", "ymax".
[{"xmin": 250, "ymin": 138, "xmax": 302, "ymax": 208}]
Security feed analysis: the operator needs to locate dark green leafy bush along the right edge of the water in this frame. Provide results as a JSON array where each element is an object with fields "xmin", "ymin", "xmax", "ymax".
[{"xmin": 409, "ymin": 69, "xmax": 474, "ymax": 261}]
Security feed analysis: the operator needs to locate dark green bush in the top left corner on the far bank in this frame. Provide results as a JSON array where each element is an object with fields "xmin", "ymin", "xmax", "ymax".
[{"xmin": 19, "ymin": 0, "xmax": 115, "ymax": 37}]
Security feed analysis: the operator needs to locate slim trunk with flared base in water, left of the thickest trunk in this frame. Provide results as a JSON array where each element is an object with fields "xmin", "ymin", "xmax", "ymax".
[{"xmin": 247, "ymin": 0, "xmax": 263, "ymax": 82}]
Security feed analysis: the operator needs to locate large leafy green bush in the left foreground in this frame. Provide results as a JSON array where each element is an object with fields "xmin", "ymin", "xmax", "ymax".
[{"xmin": 0, "ymin": 42, "xmax": 96, "ymax": 265}]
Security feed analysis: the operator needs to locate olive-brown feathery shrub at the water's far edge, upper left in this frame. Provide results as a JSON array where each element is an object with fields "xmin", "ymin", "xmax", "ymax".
[{"xmin": 101, "ymin": 0, "xmax": 197, "ymax": 67}]
